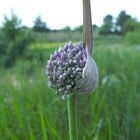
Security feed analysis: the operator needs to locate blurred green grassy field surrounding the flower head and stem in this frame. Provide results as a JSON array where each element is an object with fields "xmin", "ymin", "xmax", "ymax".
[{"xmin": 0, "ymin": 37, "xmax": 140, "ymax": 140}]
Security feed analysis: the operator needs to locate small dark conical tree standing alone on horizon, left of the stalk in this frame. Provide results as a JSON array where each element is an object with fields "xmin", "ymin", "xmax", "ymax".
[{"xmin": 33, "ymin": 15, "xmax": 48, "ymax": 32}]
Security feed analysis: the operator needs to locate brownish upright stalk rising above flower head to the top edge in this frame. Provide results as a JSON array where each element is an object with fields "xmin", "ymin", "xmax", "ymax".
[{"xmin": 83, "ymin": 0, "xmax": 93, "ymax": 54}]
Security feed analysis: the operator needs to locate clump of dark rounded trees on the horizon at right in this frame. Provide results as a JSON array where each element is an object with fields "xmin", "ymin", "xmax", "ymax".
[{"xmin": 99, "ymin": 10, "xmax": 140, "ymax": 35}]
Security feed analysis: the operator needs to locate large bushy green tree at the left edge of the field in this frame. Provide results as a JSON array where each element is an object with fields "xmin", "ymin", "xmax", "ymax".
[{"xmin": 0, "ymin": 13, "xmax": 33, "ymax": 67}]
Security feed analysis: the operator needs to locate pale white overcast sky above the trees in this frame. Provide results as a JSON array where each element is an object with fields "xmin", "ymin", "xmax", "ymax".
[{"xmin": 0, "ymin": 0, "xmax": 140, "ymax": 29}]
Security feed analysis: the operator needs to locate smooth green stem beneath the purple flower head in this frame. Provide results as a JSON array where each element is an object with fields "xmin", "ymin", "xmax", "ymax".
[{"xmin": 67, "ymin": 94, "xmax": 78, "ymax": 140}]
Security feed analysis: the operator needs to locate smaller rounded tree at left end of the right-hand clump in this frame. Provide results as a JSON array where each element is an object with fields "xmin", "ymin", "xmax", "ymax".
[{"xmin": 99, "ymin": 15, "xmax": 113, "ymax": 34}]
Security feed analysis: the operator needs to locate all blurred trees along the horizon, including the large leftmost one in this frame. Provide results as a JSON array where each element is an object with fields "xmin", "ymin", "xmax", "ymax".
[{"xmin": 0, "ymin": 11, "xmax": 140, "ymax": 67}]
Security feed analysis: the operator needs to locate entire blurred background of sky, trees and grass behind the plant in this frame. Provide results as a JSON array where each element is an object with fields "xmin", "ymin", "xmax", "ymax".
[{"xmin": 0, "ymin": 0, "xmax": 140, "ymax": 140}]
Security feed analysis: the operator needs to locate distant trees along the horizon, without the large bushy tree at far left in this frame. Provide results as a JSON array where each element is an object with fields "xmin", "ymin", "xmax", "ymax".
[{"xmin": 28, "ymin": 10, "xmax": 140, "ymax": 35}]
